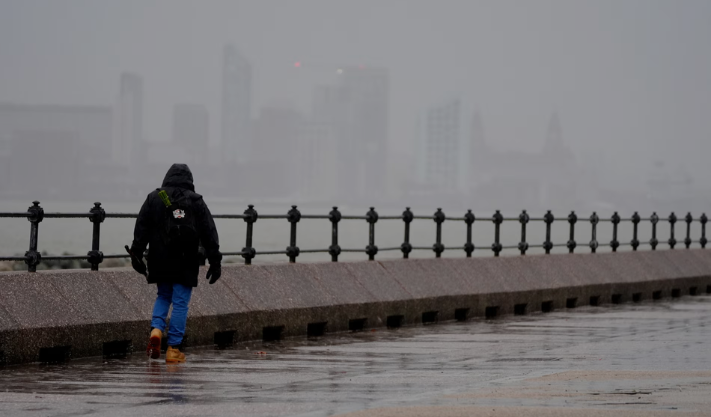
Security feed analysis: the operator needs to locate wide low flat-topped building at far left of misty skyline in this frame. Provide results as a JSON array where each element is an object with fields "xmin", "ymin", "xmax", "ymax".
[{"xmin": 0, "ymin": 103, "xmax": 112, "ymax": 198}]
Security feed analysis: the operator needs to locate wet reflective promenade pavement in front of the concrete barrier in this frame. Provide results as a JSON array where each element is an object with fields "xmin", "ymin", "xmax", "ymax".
[{"xmin": 0, "ymin": 296, "xmax": 711, "ymax": 417}]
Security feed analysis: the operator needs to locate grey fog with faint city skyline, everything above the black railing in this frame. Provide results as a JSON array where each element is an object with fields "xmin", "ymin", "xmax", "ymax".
[{"xmin": 0, "ymin": 0, "xmax": 711, "ymax": 215}]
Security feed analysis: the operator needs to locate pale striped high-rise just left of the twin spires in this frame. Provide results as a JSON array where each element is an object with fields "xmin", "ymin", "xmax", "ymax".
[{"xmin": 418, "ymin": 99, "xmax": 469, "ymax": 191}]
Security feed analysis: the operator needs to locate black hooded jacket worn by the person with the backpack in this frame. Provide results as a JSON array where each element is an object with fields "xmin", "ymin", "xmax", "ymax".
[{"xmin": 132, "ymin": 164, "xmax": 222, "ymax": 287}]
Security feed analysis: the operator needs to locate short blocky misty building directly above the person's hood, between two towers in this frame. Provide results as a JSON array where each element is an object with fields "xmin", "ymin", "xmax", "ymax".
[{"xmin": 173, "ymin": 104, "xmax": 210, "ymax": 165}]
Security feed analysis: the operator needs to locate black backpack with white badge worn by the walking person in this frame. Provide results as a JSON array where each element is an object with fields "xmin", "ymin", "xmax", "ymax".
[{"xmin": 157, "ymin": 188, "xmax": 199, "ymax": 258}]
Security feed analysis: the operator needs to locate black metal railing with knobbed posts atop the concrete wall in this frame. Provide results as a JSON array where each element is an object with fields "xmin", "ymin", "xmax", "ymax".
[{"xmin": 0, "ymin": 201, "xmax": 708, "ymax": 272}]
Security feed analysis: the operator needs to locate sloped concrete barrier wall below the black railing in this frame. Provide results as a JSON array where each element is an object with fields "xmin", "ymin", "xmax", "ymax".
[{"xmin": 0, "ymin": 249, "xmax": 711, "ymax": 364}]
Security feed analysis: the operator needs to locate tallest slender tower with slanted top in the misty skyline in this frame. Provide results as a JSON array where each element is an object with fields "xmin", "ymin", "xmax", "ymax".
[{"xmin": 221, "ymin": 45, "xmax": 252, "ymax": 164}]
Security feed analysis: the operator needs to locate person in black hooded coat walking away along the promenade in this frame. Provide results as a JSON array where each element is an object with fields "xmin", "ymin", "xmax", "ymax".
[{"xmin": 130, "ymin": 164, "xmax": 222, "ymax": 363}]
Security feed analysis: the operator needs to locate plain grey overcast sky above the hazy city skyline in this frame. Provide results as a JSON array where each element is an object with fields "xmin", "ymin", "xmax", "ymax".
[{"xmin": 0, "ymin": 0, "xmax": 711, "ymax": 185}]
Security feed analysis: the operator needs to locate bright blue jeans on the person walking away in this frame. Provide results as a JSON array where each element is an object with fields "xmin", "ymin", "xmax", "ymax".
[{"xmin": 151, "ymin": 283, "xmax": 193, "ymax": 346}]
